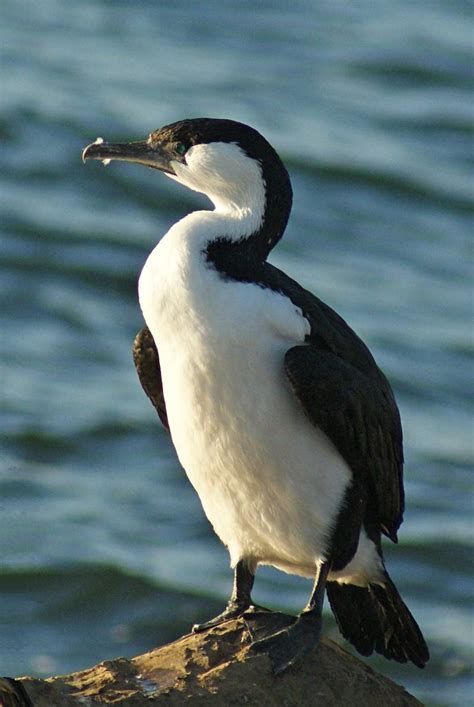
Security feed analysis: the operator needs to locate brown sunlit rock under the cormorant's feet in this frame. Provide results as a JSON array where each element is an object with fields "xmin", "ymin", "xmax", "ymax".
[{"xmin": 4, "ymin": 614, "xmax": 421, "ymax": 707}]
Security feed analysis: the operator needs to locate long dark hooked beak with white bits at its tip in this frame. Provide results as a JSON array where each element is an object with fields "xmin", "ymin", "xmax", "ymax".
[{"xmin": 82, "ymin": 137, "xmax": 176, "ymax": 175}]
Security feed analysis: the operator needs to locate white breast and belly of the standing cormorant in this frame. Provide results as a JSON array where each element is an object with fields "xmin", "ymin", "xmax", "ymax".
[{"xmin": 139, "ymin": 212, "xmax": 350, "ymax": 575}]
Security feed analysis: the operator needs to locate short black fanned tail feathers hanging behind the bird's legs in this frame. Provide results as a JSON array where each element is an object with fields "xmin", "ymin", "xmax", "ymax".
[{"xmin": 326, "ymin": 574, "xmax": 430, "ymax": 668}]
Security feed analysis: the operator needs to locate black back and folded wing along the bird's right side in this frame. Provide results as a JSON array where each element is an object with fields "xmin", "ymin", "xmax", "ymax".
[{"xmin": 262, "ymin": 263, "xmax": 404, "ymax": 542}]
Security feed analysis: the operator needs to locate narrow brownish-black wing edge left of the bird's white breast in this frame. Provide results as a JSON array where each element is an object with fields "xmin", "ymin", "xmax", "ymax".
[{"xmin": 132, "ymin": 326, "xmax": 170, "ymax": 432}]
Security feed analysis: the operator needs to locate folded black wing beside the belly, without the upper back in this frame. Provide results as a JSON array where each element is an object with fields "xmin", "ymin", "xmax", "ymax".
[{"xmin": 285, "ymin": 344, "xmax": 403, "ymax": 541}]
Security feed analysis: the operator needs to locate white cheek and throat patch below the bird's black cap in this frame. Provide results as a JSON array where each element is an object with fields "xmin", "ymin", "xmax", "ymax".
[{"xmin": 167, "ymin": 142, "xmax": 266, "ymax": 239}]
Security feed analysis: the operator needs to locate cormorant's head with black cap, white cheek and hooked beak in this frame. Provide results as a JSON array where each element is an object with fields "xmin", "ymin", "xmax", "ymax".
[{"xmin": 82, "ymin": 118, "xmax": 292, "ymax": 254}]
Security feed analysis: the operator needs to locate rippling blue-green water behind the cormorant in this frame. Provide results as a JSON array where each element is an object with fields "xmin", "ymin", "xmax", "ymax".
[{"xmin": 0, "ymin": 0, "xmax": 473, "ymax": 705}]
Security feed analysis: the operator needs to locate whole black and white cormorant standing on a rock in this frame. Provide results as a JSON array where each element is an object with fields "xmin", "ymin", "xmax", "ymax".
[{"xmin": 83, "ymin": 118, "xmax": 429, "ymax": 673}]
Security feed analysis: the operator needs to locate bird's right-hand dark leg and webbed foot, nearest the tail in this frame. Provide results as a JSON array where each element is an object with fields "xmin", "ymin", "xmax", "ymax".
[{"xmin": 252, "ymin": 562, "xmax": 330, "ymax": 675}]
